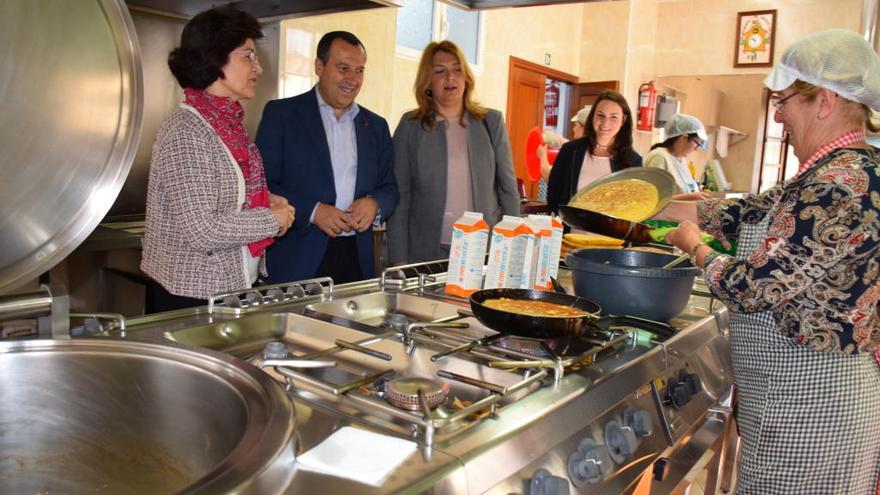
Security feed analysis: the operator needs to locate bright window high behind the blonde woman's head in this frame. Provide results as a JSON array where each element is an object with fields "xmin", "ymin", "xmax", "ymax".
[{"xmin": 397, "ymin": 0, "xmax": 483, "ymax": 65}]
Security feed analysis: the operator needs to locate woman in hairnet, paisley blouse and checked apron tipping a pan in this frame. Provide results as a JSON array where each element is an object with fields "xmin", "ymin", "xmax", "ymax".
[{"xmin": 658, "ymin": 29, "xmax": 880, "ymax": 495}]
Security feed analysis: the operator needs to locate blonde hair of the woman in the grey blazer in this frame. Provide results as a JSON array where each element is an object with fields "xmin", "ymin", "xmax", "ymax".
[{"xmin": 410, "ymin": 40, "xmax": 487, "ymax": 129}]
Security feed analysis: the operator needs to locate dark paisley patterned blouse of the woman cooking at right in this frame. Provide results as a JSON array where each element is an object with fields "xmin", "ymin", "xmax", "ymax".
[{"xmin": 698, "ymin": 148, "xmax": 880, "ymax": 354}]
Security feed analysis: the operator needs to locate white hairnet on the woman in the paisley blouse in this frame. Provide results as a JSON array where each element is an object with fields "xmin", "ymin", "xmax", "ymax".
[{"xmin": 764, "ymin": 29, "xmax": 880, "ymax": 110}]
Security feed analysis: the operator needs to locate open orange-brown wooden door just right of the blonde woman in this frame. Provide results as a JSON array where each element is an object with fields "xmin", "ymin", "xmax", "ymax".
[{"xmin": 507, "ymin": 57, "xmax": 577, "ymax": 198}]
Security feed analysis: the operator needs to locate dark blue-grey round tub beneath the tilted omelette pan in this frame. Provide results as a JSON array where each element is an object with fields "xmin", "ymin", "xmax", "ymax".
[{"xmin": 565, "ymin": 249, "xmax": 702, "ymax": 322}]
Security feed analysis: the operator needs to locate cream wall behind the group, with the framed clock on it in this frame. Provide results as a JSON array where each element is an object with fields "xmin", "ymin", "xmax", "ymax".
[{"xmin": 282, "ymin": 0, "xmax": 861, "ymax": 190}]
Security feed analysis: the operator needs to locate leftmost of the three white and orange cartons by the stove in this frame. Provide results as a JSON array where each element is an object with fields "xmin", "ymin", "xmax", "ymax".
[{"xmin": 446, "ymin": 211, "xmax": 489, "ymax": 297}]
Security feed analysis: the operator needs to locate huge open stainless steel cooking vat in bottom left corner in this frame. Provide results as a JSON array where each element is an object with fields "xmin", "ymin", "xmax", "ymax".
[{"xmin": 0, "ymin": 339, "xmax": 294, "ymax": 494}]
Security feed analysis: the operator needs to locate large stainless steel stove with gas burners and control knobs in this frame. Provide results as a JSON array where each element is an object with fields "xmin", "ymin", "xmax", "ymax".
[{"xmin": 124, "ymin": 273, "xmax": 731, "ymax": 495}]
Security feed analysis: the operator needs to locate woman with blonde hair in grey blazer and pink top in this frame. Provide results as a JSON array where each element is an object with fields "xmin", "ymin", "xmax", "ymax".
[{"xmin": 388, "ymin": 41, "xmax": 520, "ymax": 264}]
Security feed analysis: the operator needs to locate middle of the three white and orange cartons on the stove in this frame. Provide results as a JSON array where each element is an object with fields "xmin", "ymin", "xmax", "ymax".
[{"xmin": 483, "ymin": 215, "xmax": 534, "ymax": 289}]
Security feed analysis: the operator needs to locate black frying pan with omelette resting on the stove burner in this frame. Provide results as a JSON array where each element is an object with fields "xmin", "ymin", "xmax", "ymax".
[{"xmin": 470, "ymin": 289, "xmax": 675, "ymax": 339}]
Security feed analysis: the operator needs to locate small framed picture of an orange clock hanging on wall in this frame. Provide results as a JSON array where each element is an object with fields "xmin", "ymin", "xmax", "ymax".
[{"xmin": 733, "ymin": 10, "xmax": 776, "ymax": 67}]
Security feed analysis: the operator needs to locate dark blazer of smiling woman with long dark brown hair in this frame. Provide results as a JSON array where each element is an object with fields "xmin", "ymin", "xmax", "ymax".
[{"xmin": 547, "ymin": 138, "xmax": 642, "ymax": 214}]
